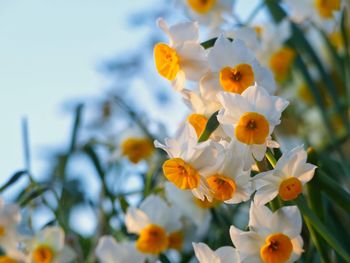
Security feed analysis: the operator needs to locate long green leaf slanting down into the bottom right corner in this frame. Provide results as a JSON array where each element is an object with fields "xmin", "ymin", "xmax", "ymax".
[{"xmin": 294, "ymin": 195, "xmax": 350, "ymax": 262}]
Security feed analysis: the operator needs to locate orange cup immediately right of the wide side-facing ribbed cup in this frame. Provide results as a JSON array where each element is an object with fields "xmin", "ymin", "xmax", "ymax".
[{"xmin": 207, "ymin": 174, "xmax": 236, "ymax": 201}]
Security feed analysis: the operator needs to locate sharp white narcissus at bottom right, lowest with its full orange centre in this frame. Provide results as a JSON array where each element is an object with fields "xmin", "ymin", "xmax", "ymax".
[{"xmin": 230, "ymin": 203, "xmax": 303, "ymax": 263}]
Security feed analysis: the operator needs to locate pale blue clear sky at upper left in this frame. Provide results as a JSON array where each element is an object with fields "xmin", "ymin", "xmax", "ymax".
[{"xmin": 0, "ymin": 0, "xmax": 156, "ymax": 182}]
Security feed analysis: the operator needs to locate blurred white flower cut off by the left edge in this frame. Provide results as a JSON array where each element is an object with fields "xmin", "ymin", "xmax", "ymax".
[{"xmin": 0, "ymin": 198, "xmax": 21, "ymax": 250}]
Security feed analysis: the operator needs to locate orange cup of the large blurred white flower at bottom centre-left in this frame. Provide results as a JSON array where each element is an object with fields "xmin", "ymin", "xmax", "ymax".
[{"xmin": 136, "ymin": 224, "xmax": 169, "ymax": 255}]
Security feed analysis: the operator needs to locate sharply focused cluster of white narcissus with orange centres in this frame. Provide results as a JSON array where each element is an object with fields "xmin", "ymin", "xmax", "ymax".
[{"xmin": 153, "ymin": 16, "xmax": 316, "ymax": 262}]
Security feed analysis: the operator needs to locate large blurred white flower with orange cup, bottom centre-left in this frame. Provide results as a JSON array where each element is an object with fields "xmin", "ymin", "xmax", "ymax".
[{"xmin": 125, "ymin": 195, "xmax": 181, "ymax": 255}]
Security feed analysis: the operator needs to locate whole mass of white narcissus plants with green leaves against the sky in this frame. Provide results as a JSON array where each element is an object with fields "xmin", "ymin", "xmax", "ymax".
[{"xmin": 0, "ymin": 0, "xmax": 350, "ymax": 263}]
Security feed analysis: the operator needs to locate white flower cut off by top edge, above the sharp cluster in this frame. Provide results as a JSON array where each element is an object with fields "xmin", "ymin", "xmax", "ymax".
[{"xmin": 175, "ymin": 0, "xmax": 235, "ymax": 31}]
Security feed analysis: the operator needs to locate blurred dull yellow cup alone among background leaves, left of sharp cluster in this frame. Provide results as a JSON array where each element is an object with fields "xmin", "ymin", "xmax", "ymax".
[{"xmin": 121, "ymin": 138, "xmax": 154, "ymax": 163}]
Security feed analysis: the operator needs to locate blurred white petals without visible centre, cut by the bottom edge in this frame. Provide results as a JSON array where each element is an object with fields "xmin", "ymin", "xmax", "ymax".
[{"xmin": 96, "ymin": 236, "xmax": 146, "ymax": 263}]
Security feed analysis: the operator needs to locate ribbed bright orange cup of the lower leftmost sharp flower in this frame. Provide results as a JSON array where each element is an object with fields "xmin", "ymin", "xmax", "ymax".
[{"xmin": 163, "ymin": 158, "xmax": 200, "ymax": 189}]
